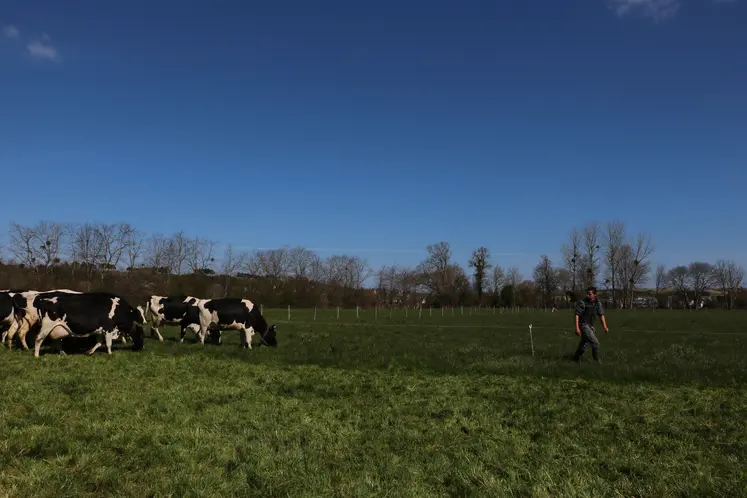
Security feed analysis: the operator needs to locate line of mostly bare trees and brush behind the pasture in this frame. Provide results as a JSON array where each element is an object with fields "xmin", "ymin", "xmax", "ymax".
[{"xmin": 0, "ymin": 221, "xmax": 747, "ymax": 309}]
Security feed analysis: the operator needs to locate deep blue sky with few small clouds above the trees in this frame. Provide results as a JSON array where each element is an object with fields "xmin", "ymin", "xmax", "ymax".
[{"xmin": 0, "ymin": 0, "xmax": 747, "ymax": 276}]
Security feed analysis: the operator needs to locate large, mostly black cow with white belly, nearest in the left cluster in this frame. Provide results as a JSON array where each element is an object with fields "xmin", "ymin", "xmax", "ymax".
[{"xmin": 34, "ymin": 292, "xmax": 145, "ymax": 358}]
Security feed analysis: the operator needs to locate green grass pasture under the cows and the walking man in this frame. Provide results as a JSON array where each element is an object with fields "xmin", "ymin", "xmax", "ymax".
[{"xmin": 0, "ymin": 309, "xmax": 747, "ymax": 497}]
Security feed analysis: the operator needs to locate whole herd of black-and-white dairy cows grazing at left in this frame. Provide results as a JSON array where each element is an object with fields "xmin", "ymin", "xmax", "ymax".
[{"xmin": 0, "ymin": 289, "xmax": 277, "ymax": 357}]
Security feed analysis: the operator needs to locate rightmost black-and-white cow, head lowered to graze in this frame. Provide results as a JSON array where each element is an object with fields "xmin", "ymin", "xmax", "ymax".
[{"xmin": 197, "ymin": 298, "xmax": 278, "ymax": 349}]
